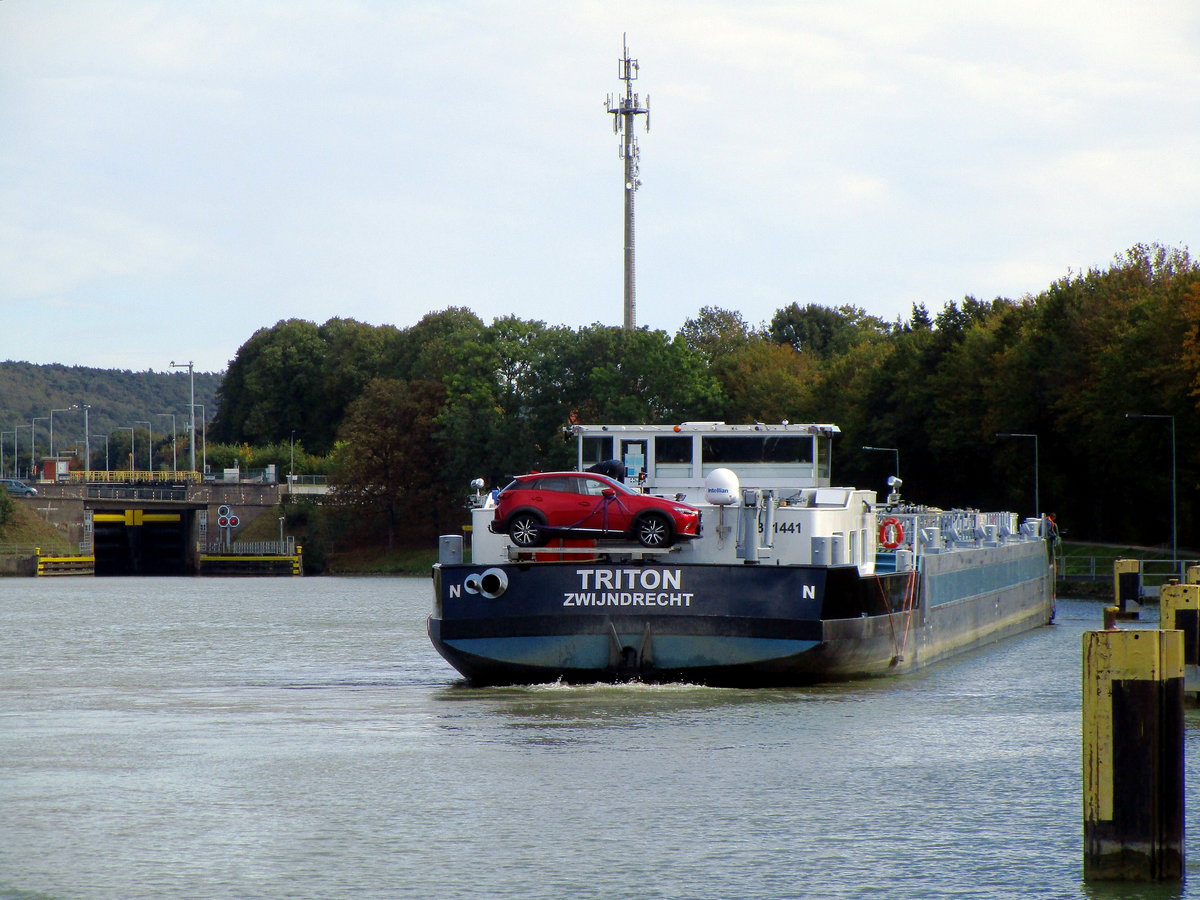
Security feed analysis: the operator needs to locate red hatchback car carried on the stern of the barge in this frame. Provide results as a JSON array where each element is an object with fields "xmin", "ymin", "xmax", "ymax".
[{"xmin": 488, "ymin": 472, "xmax": 700, "ymax": 547}]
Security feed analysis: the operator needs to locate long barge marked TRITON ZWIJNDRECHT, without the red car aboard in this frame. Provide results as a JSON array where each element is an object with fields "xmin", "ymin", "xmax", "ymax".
[{"xmin": 428, "ymin": 422, "xmax": 1055, "ymax": 686}]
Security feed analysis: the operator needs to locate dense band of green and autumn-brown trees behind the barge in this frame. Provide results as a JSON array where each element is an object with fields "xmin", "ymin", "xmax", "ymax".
[{"xmin": 209, "ymin": 245, "xmax": 1200, "ymax": 546}]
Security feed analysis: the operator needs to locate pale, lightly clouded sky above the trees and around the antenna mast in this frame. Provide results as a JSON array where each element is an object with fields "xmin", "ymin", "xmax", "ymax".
[{"xmin": 0, "ymin": 0, "xmax": 1200, "ymax": 372}]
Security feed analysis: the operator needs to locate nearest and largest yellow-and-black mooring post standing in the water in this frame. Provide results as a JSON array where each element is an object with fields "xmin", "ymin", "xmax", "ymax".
[{"xmin": 1082, "ymin": 629, "xmax": 1183, "ymax": 881}]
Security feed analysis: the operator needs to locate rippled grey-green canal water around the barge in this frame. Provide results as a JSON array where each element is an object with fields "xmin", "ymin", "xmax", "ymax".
[{"xmin": 0, "ymin": 577, "xmax": 1200, "ymax": 900}]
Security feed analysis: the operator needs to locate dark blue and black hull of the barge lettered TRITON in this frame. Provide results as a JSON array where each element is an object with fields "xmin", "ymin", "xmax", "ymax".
[{"xmin": 428, "ymin": 542, "xmax": 1054, "ymax": 686}]
